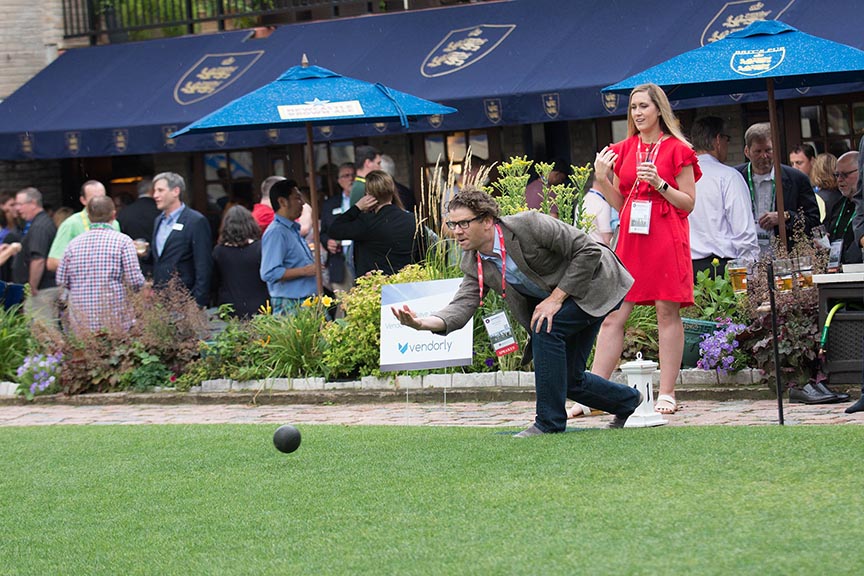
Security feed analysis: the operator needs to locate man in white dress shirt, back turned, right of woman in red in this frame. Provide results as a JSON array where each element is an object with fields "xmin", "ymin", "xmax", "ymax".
[{"xmin": 688, "ymin": 116, "xmax": 759, "ymax": 282}]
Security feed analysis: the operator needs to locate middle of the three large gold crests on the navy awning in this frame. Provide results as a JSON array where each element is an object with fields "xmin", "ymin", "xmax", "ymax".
[{"xmin": 420, "ymin": 24, "xmax": 516, "ymax": 78}]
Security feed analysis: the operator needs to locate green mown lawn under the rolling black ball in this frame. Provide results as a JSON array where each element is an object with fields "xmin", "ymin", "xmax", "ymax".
[{"xmin": 0, "ymin": 425, "xmax": 864, "ymax": 576}]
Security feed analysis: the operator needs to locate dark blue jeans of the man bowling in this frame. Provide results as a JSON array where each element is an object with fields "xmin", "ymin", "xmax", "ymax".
[{"xmin": 531, "ymin": 298, "xmax": 639, "ymax": 432}]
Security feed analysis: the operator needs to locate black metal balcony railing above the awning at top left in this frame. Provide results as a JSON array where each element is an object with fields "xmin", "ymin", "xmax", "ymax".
[{"xmin": 62, "ymin": 0, "xmax": 400, "ymax": 44}]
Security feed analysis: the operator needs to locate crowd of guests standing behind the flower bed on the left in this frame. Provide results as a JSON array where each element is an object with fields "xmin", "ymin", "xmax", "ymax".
[{"xmin": 0, "ymin": 146, "xmax": 427, "ymax": 330}]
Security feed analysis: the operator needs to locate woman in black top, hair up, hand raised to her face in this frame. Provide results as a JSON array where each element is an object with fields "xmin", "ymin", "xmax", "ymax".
[{"xmin": 328, "ymin": 170, "xmax": 426, "ymax": 278}]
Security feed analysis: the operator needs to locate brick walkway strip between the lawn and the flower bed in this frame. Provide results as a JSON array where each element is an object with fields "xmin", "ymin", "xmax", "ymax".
[{"xmin": 0, "ymin": 400, "xmax": 864, "ymax": 429}]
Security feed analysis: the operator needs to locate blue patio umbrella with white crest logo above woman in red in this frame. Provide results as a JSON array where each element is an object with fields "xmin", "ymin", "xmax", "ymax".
[{"xmin": 602, "ymin": 20, "xmax": 864, "ymax": 246}]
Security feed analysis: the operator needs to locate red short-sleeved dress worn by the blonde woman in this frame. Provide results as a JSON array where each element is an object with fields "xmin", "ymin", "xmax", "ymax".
[{"xmin": 612, "ymin": 134, "xmax": 702, "ymax": 307}]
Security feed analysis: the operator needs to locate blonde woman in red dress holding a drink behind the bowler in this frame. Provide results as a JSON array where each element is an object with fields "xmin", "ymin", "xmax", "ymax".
[{"xmin": 591, "ymin": 84, "xmax": 702, "ymax": 414}]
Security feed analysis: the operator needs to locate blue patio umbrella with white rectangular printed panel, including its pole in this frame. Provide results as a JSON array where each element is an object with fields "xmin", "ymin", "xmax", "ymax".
[{"xmin": 171, "ymin": 55, "xmax": 456, "ymax": 294}]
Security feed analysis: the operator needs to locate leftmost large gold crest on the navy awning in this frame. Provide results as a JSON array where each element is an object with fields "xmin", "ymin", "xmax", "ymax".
[{"xmin": 174, "ymin": 50, "xmax": 264, "ymax": 106}]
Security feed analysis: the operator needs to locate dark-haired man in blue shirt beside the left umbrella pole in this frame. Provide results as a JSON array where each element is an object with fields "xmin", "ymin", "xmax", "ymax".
[{"xmin": 261, "ymin": 180, "xmax": 317, "ymax": 314}]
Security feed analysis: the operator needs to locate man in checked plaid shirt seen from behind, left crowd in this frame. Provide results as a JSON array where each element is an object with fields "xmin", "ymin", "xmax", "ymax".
[{"xmin": 57, "ymin": 196, "xmax": 144, "ymax": 332}]
